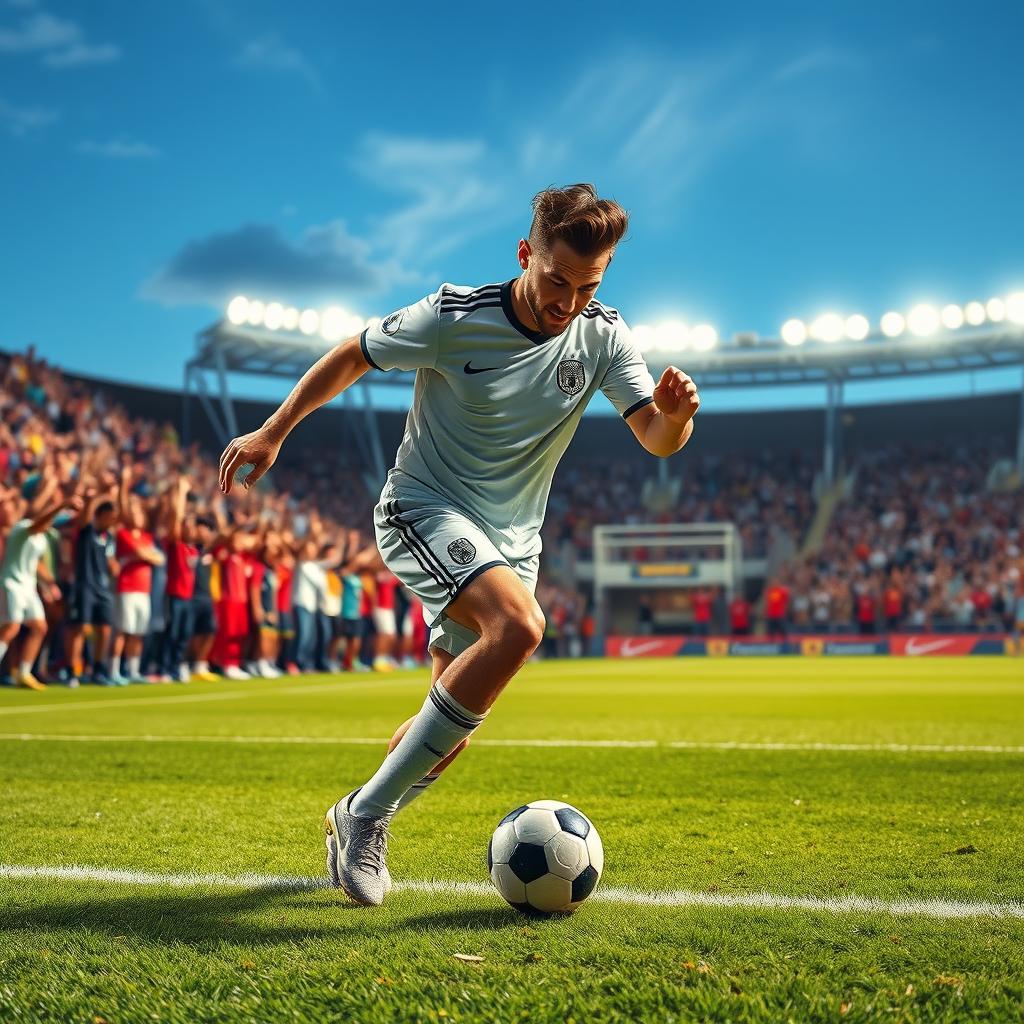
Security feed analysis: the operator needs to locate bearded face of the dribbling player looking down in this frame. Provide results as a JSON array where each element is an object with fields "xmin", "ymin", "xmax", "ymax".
[{"xmin": 519, "ymin": 239, "xmax": 611, "ymax": 335}]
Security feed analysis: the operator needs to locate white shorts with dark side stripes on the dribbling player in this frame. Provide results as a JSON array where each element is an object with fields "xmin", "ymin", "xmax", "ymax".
[{"xmin": 374, "ymin": 488, "xmax": 541, "ymax": 654}]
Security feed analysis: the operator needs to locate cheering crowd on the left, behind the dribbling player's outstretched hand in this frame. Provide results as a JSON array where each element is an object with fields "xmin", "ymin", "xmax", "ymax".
[{"xmin": 0, "ymin": 350, "xmax": 426, "ymax": 689}]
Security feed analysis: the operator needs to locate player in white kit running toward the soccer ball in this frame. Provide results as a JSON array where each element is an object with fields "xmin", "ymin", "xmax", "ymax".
[{"xmin": 220, "ymin": 184, "xmax": 699, "ymax": 906}]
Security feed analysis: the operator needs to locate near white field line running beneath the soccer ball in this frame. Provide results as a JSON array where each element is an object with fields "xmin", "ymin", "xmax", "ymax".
[{"xmin": 0, "ymin": 864, "xmax": 1024, "ymax": 920}]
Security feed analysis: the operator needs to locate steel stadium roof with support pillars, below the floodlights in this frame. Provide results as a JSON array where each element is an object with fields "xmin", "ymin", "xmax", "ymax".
[{"xmin": 183, "ymin": 317, "xmax": 1024, "ymax": 484}]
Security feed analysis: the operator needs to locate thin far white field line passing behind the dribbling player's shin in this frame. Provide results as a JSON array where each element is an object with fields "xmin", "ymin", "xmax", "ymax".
[{"xmin": 0, "ymin": 733, "xmax": 1024, "ymax": 754}]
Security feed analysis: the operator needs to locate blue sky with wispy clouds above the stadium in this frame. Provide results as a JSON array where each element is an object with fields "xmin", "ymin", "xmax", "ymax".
[{"xmin": 0, "ymin": 0, "xmax": 1024, "ymax": 407}]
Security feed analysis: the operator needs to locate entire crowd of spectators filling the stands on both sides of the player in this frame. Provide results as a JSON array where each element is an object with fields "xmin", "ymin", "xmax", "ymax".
[{"xmin": 0, "ymin": 351, "xmax": 1024, "ymax": 687}]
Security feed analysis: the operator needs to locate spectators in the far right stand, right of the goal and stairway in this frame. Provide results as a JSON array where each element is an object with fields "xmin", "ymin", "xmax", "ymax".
[{"xmin": 764, "ymin": 438, "xmax": 1024, "ymax": 634}]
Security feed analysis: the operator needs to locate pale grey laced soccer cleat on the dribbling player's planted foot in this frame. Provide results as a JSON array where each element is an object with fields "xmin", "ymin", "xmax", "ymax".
[{"xmin": 325, "ymin": 790, "xmax": 391, "ymax": 906}]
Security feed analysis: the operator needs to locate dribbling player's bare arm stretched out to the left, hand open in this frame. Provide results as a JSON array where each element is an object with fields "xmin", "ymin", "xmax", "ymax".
[{"xmin": 220, "ymin": 336, "xmax": 370, "ymax": 495}]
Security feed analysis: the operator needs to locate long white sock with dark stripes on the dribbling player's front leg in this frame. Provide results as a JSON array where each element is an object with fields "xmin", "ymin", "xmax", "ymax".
[{"xmin": 348, "ymin": 682, "xmax": 484, "ymax": 818}]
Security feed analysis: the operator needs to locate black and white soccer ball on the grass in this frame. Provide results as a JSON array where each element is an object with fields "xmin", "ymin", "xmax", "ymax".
[{"xmin": 487, "ymin": 800, "xmax": 604, "ymax": 913}]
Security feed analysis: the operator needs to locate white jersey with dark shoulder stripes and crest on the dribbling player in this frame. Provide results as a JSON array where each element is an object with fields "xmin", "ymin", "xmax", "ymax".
[{"xmin": 360, "ymin": 281, "xmax": 654, "ymax": 557}]
